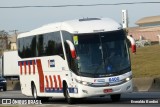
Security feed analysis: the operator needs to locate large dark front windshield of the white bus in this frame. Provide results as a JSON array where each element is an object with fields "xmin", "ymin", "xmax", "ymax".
[{"xmin": 74, "ymin": 30, "xmax": 131, "ymax": 77}]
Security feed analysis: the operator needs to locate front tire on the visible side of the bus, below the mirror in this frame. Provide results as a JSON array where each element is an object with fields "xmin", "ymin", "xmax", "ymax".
[{"xmin": 64, "ymin": 84, "xmax": 75, "ymax": 104}]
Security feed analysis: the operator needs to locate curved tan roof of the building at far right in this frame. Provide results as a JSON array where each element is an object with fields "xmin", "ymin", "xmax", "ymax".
[{"xmin": 136, "ymin": 16, "xmax": 160, "ymax": 25}]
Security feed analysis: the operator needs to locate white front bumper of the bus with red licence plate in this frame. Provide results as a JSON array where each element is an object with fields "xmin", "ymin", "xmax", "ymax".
[{"xmin": 70, "ymin": 79, "xmax": 133, "ymax": 98}]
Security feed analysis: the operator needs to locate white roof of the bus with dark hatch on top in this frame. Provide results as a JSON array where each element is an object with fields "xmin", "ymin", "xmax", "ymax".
[{"xmin": 18, "ymin": 18, "xmax": 122, "ymax": 38}]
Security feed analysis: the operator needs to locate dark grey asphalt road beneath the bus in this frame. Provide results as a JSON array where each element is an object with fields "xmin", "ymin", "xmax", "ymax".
[{"xmin": 0, "ymin": 91, "xmax": 160, "ymax": 107}]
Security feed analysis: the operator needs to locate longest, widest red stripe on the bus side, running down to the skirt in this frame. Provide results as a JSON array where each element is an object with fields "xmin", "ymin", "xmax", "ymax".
[{"xmin": 36, "ymin": 59, "xmax": 44, "ymax": 92}]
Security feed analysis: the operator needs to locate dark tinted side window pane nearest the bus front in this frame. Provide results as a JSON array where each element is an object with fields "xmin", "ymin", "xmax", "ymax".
[{"xmin": 37, "ymin": 32, "xmax": 63, "ymax": 56}]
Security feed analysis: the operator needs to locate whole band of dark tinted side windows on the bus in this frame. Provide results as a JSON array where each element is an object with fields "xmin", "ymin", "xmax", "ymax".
[{"xmin": 18, "ymin": 32, "xmax": 63, "ymax": 58}]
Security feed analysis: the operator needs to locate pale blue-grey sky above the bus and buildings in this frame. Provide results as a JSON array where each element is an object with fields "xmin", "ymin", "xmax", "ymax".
[{"xmin": 0, "ymin": 0, "xmax": 160, "ymax": 32}]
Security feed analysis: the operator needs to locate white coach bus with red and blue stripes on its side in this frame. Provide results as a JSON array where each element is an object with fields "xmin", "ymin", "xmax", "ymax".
[{"xmin": 18, "ymin": 18, "xmax": 135, "ymax": 103}]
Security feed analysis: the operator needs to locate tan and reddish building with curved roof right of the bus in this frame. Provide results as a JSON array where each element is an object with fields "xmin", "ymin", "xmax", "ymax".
[{"xmin": 128, "ymin": 16, "xmax": 160, "ymax": 42}]
